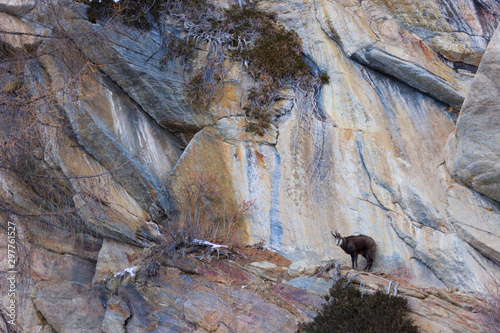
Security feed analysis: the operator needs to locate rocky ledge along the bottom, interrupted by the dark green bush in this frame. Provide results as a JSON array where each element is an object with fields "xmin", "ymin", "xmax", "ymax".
[{"xmin": 24, "ymin": 245, "xmax": 492, "ymax": 333}]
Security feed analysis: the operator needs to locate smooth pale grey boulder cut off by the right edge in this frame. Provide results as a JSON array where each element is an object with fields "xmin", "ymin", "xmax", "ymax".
[{"xmin": 447, "ymin": 25, "xmax": 500, "ymax": 201}]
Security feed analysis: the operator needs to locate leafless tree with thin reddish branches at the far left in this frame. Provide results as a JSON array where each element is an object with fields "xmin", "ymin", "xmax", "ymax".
[{"xmin": 0, "ymin": 35, "xmax": 118, "ymax": 227}]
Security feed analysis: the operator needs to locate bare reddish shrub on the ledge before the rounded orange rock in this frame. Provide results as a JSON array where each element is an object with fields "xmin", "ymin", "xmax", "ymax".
[{"xmin": 140, "ymin": 172, "xmax": 254, "ymax": 279}]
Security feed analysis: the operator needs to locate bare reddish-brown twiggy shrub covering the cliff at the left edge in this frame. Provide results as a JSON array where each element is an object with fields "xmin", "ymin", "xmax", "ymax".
[{"xmin": 0, "ymin": 22, "xmax": 132, "ymax": 231}]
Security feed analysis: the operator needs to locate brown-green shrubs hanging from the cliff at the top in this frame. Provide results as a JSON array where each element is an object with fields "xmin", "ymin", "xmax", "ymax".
[{"xmin": 84, "ymin": 0, "xmax": 329, "ymax": 135}]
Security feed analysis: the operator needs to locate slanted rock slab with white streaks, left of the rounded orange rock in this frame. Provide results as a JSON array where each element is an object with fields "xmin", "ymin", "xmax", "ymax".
[{"xmin": 32, "ymin": 41, "xmax": 180, "ymax": 210}]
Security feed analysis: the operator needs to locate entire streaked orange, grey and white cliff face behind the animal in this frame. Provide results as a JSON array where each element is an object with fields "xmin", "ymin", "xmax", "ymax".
[{"xmin": 0, "ymin": 0, "xmax": 500, "ymax": 332}]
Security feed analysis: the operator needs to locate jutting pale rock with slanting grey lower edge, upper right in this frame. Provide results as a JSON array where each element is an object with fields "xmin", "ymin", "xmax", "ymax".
[{"xmin": 300, "ymin": 1, "xmax": 487, "ymax": 107}]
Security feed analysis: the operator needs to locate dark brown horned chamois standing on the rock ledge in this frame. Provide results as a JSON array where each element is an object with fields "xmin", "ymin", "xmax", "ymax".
[{"xmin": 330, "ymin": 230, "xmax": 377, "ymax": 271}]
